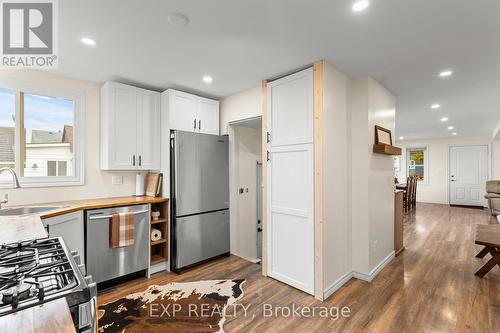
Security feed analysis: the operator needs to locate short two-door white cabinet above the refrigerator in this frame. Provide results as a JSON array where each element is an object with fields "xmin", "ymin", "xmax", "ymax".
[{"xmin": 162, "ymin": 89, "xmax": 219, "ymax": 135}]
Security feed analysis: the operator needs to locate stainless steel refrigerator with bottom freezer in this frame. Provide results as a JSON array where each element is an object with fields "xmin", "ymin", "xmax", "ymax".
[{"xmin": 170, "ymin": 131, "xmax": 229, "ymax": 273}]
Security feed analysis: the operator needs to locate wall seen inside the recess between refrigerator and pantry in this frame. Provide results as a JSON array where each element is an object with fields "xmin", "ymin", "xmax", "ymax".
[{"xmin": 230, "ymin": 126, "xmax": 262, "ymax": 261}]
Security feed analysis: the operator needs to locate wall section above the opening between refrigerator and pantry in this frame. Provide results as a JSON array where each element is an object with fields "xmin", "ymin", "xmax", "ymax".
[{"xmin": 220, "ymin": 86, "xmax": 262, "ymax": 135}]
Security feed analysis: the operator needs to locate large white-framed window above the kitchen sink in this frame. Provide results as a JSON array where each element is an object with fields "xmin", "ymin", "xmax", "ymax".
[{"xmin": 0, "ymin": 81, "xmax": 83, "ymax": 186}]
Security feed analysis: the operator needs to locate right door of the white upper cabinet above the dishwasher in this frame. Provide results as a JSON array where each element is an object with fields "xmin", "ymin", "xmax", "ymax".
[{"xmin": 137, "ymin": 89, "xmax": 160, "ymax": 170}]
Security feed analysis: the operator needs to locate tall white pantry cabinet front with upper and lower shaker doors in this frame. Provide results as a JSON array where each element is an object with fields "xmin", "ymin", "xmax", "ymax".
[{"xmin": 267, "ymin": 69, "xmax": 314, "ymax": 294}]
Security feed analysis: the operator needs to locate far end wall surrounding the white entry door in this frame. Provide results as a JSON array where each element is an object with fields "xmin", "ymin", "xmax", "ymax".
[{"xmin": 396, "ymin": 136, "xmax": 500, "ymax": 204}]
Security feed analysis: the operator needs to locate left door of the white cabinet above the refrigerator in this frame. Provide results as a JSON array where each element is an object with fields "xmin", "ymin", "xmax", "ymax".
[{"xmin": 169, "ymin": 90, "xmax": 197, "ymax": 132}]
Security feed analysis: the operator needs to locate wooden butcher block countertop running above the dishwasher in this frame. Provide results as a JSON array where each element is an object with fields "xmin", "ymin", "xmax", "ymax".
[{"xmin": 30, "ymin": 196, "xmax": 168, "ymax": 219}]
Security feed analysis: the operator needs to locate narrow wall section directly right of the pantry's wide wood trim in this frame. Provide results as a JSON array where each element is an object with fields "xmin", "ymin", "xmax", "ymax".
[{"xmin": 323, "ymin": 62, "xmax": 352, "ymax": 291}]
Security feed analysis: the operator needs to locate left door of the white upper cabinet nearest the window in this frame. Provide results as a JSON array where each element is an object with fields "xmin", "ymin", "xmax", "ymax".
[{"xmin": 101, "ymin": 82, "xmax": 138, "ymax": 170}]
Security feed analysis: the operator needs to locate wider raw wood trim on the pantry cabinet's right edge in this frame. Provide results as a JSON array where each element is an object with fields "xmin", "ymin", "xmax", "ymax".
[{"xmin": 313, "ymin": 60, "xmax": 324, "ymax": 301}]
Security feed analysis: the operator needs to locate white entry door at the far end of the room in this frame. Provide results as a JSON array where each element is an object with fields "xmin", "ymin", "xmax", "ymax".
[{"xmin": 450, "ymin": 145, "xmax": 488, "ymax": 206}]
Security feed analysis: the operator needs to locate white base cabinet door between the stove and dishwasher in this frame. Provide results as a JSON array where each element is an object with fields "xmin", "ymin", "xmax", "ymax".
[{"xmin": 42, "ymin": 211, "xmax": 85, "ymax": 263}]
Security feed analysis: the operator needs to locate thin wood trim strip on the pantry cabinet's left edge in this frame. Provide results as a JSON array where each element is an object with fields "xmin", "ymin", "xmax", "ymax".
[{"xmin": 262, "ymin": 80, "xmax": 268, "ymax": 276}]
